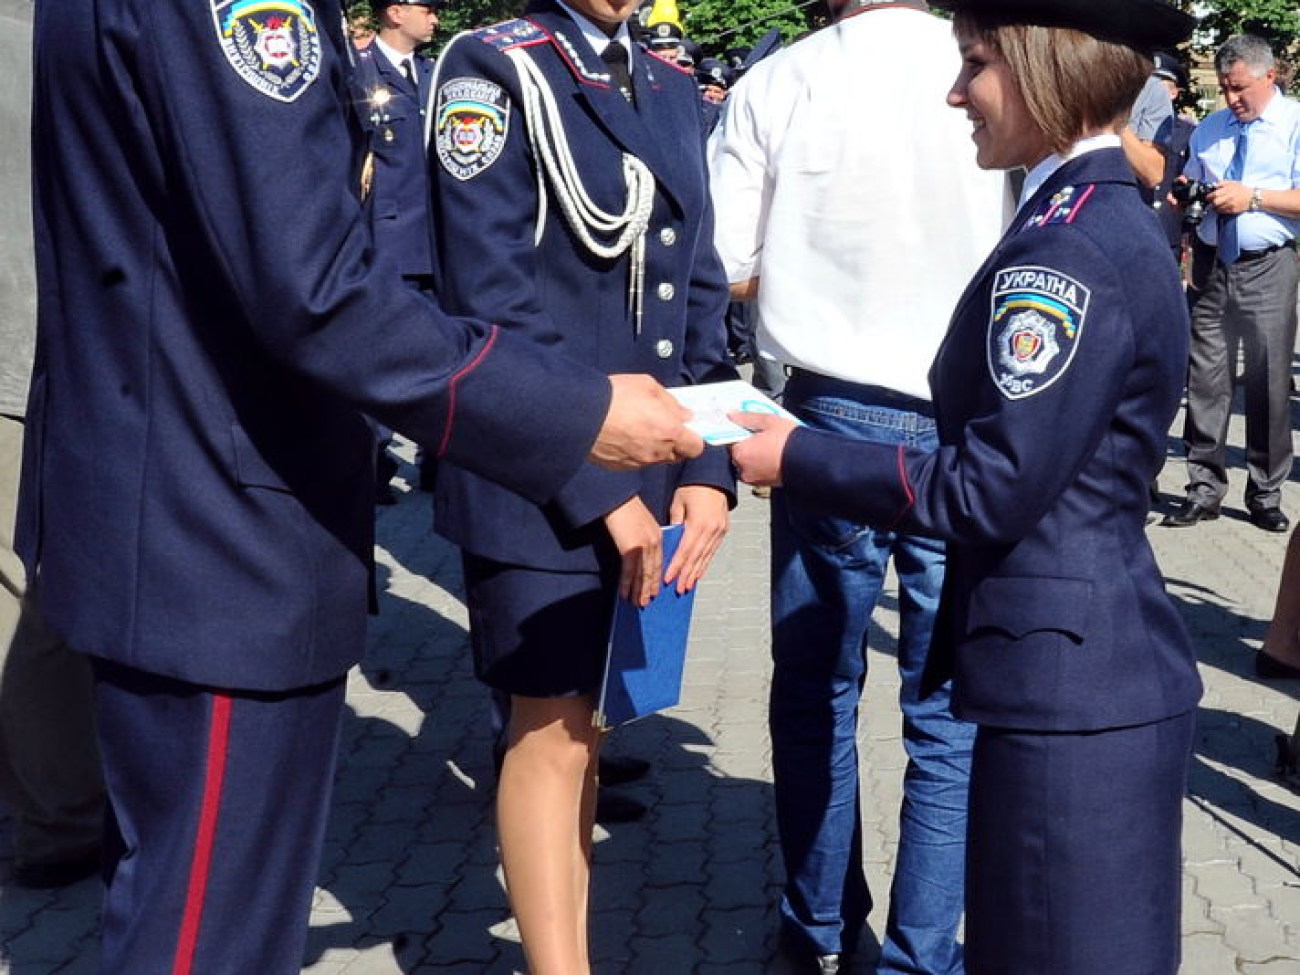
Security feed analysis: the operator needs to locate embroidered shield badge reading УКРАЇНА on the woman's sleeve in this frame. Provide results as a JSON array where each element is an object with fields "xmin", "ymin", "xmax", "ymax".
[{"xmin": 988, "ymin": 267, "xmax": 1092, "ymax": 399}]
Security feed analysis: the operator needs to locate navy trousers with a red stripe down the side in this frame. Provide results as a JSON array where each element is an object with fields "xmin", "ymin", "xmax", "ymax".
[{"xmin": 95, "ymin": 660, "xmax": 345, "ymax": 975}]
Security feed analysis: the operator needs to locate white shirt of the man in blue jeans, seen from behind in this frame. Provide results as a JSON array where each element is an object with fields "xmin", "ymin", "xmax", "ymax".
[{"xmin": 710, "ymin": 8, "xmax": 1009, "ymax": 399}]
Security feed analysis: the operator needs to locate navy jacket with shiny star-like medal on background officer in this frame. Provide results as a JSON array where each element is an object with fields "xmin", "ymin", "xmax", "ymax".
[{"xmin": 352, "ymin": 40, "xmax": 433, "ymax": 277}]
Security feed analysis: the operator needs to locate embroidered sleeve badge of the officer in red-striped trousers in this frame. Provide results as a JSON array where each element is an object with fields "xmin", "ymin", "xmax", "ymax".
[{"xmin": 209, "ymin": 0, "xmax": 321, "ymax": 101}]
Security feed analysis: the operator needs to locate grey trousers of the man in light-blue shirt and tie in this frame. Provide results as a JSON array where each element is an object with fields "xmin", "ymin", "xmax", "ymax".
[{"xmin": 1183, "ymin": 243, "xmax": 1297, "ymax": 511}]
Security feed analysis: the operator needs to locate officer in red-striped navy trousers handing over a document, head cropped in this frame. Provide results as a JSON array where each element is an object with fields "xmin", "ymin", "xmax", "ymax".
[{"xmin": 17, "ymin": 0, "xmax": 703, "ymax": 975}]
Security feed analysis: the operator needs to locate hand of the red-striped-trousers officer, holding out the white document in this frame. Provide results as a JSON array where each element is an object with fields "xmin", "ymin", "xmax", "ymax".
[{"xmin": 589, "ymin": 374, "xmax": 705, "ymax": 471}]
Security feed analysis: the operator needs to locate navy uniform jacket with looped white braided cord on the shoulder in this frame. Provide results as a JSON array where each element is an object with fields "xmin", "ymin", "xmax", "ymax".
[{"xmin": 429, "ymin": 3, "xmax": 733, "ymax": 569}]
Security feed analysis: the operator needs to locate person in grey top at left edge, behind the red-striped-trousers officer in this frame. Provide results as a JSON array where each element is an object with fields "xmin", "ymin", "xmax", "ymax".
[{"xmin": 0, "ymin": 0, "xmax": 104, "ymax": 888}]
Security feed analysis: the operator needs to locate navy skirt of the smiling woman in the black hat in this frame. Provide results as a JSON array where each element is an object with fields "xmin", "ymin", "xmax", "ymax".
[{"xmin": 966, "ymin": 711, "xmax": 1196, "ymax": 975}]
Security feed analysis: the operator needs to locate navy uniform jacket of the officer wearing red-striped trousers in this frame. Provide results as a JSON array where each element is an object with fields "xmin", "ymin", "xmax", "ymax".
[{"xmin": 18, "ymin": 0, "xmax": 611, "ymax": 689}]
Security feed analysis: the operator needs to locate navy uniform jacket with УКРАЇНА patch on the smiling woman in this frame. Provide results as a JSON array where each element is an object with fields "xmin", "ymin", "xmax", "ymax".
[{"xmin": 783, "ymin": 148, "xmax": 1200, "ymax": 731}]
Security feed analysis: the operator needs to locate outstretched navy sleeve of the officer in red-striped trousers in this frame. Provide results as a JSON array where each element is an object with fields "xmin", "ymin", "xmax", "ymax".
[{"xmin": 131, "ymin": 0, "xmax": 611, "ymax": 502}]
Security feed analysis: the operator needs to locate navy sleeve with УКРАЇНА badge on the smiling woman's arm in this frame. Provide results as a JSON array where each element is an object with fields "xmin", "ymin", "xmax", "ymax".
[{"xmin": 781, "ymin": 228, "xmax": 1135, "ymax": 545}]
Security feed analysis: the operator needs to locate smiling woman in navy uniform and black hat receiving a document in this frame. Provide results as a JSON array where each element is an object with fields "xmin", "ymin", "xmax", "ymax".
[{"xmin": 732, "ymin": 0, "xmax": 1201, "ymax": 975}]
